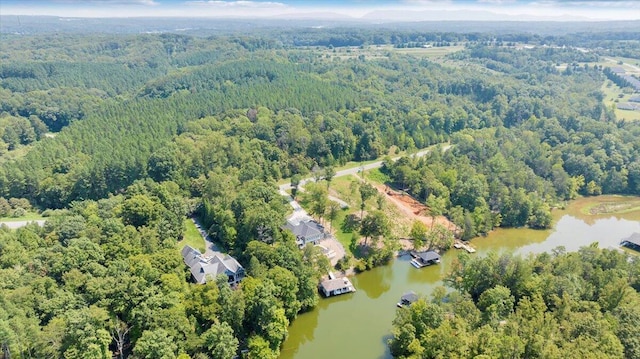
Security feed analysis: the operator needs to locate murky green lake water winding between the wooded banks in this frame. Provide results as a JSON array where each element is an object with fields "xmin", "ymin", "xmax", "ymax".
[{"xmin": 280, "ymin": 196, "xmax": 640, "ymax": 359}]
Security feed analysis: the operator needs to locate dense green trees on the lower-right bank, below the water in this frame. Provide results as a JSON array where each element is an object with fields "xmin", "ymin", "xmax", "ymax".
[{"xmin": 389, "ymin": 248, "xmax": 640, "ymax": 358}]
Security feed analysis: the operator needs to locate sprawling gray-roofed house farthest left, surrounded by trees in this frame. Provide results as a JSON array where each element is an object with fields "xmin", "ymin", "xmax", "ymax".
[{"xmin": 182, "ymin": 246, "xmax": 244, "ymax": 285}]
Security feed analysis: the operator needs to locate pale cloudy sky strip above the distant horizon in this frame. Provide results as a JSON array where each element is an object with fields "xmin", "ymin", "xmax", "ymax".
[{"xmin": 0, "ymin": 0, "xmax": 640, "ymax": 21}]
